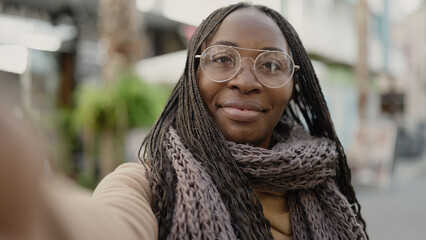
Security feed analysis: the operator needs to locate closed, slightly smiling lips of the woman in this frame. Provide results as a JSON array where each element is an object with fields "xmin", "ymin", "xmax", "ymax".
[{"xmin": 219, "ymin": 99, "xmax": 266, "ymax": 122}]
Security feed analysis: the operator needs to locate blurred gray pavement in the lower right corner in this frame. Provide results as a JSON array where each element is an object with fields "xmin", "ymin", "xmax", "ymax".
[{"xmin": 356, "ymin": 154, "xmax": 426, "ymax": 240}]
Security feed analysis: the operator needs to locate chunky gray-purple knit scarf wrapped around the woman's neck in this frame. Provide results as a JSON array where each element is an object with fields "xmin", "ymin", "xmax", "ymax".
[{"xmin": 164, "ymin": 127, "xmax": 366, "ymax": 239}]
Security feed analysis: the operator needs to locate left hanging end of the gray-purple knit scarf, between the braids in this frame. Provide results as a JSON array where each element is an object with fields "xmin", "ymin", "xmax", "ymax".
[{"xmin": 165, "ymin": 128, "xmax": 236, "ymax": 240}]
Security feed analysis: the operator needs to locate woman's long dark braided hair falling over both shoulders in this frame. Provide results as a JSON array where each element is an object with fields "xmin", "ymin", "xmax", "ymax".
[{"xmin": 141, "ymin": 3, "xmax": 365, "ymax": 239}]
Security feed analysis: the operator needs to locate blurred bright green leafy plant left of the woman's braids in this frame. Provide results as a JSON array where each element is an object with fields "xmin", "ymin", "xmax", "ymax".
[{"xmin": 74, "ymin": 74, "xmax": 170, "ymax": 134}]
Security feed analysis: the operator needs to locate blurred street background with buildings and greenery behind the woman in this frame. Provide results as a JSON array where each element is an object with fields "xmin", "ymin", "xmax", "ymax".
[{"xmin": 0, "ymin": 0, "xmax": 426, "ymax": 239}]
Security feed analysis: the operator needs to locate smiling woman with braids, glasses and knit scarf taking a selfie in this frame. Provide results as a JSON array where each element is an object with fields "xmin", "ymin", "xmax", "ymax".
[{"xmin": 0, "ymin": 3, "xmax": 367, "ymax": 239}]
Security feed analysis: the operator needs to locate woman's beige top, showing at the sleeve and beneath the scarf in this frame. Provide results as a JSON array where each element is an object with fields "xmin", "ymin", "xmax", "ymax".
[{"xmin": 47, "ymin": 163, "xmax": 293, "ymax": 240}]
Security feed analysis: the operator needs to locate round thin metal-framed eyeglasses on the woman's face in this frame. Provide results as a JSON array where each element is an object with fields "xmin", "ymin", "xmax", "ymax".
[{"xmin": 195, "ymin": 45, "xmax": 300, "ymax": 88}]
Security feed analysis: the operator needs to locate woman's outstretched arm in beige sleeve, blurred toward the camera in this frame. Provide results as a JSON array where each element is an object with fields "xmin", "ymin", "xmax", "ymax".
[{"xmin": 0, "ymin": 108, "xmax": 158, "ymax": 240}]
